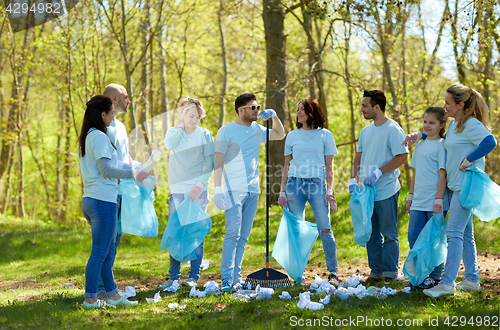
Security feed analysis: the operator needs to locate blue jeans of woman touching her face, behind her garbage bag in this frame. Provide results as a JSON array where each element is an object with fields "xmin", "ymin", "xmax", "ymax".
[{"xmin": 168, "ymin": 191, "xmax": 208, "ymax": 281}]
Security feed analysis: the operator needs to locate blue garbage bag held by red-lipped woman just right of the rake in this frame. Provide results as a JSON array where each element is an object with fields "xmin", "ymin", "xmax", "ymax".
[{"xmin": 272, "ymin": 208, "xmax": 319, "ymax": 283}]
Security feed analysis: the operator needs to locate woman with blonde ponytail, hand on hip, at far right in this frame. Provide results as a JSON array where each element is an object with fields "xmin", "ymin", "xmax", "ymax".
[{"xmin": 405, "ymin": 83, "xmax": 497, "ymax": 297}]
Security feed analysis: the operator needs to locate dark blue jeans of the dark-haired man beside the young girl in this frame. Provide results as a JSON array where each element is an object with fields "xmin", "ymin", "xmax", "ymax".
[{"xmin": 366, "ymin": 191, "xmax": 399, "ymax": 278}]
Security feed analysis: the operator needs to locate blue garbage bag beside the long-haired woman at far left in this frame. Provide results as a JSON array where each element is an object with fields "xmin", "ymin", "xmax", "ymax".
[{"xmin": 120, "ymin": 176, "xmax": 158, "ymax": 237}]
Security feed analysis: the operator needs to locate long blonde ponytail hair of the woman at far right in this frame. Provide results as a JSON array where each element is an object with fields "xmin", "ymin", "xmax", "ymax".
[{"xmin": 446, "ymin": 83, "xmax": 491, "ymax": 133}]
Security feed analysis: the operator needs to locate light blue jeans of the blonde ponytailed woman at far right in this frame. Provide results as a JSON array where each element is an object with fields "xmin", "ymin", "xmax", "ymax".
[{"xmin": 442, "ymin": 190, "xmax": 479, "ymax": 285}]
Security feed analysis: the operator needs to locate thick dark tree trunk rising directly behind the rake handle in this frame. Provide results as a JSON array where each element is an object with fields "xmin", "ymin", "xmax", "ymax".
[{"xmin": 262, "ymin": 0, "xmax": 288, "ymax": 202}]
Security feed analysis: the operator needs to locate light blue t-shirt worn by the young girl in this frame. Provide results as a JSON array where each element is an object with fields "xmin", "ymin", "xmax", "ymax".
[{"xmin": 410, "ymin": 139, "xmax": 449, "ymax": 211}]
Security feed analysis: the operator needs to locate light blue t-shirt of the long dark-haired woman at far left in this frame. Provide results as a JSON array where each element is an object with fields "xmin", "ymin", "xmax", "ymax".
[{"xmin": 80, "ymin": 129, "xmax": 118, "ymax": 203}]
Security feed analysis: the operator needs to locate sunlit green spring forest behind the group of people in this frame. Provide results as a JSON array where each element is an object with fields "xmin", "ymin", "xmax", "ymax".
[{"xmin": 0, "ymin": 0, "xmax": 500, "ymax": 223}]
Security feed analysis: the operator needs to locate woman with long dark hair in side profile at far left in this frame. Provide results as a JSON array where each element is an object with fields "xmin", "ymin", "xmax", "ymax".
[{"xmin": 78, "ymin": 95, "xmax": 148, "ymax": 308}]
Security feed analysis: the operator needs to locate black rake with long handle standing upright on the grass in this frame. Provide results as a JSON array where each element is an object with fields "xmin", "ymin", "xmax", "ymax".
[{"xmin": 245, "ymin": 120, "xmax": 292, "ymax": 288}]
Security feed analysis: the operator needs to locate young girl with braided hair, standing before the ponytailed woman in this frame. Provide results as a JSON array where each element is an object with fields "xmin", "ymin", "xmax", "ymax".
[{"xmin": 406, "ymin": 107, "xmax": 449, "ymax": 289}]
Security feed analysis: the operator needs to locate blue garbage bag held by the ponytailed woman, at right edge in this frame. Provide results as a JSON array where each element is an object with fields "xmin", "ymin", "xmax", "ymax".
[{"xmin": 460, "ymin": 166, "xmax": 500, "ymax": 221}]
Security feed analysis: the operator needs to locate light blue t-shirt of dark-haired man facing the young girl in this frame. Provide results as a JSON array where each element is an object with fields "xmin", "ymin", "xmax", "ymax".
[{"xmin": 357, "ymin": 119, "xmax": 408, "ymax": 201}]
